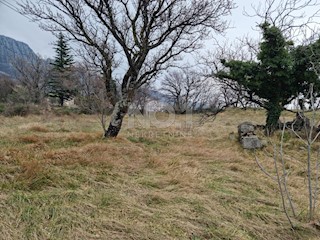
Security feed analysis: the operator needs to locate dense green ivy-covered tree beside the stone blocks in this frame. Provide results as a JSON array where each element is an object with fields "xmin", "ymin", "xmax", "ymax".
[{"xmin": 217, "ymin": 23, "xmax": 319, "ymax": 134}]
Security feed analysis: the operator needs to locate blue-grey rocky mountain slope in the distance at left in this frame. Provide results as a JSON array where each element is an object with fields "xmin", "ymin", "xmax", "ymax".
[{"xmin": 0, "ymin": 35, "xmax": 37, "ymax": 76}]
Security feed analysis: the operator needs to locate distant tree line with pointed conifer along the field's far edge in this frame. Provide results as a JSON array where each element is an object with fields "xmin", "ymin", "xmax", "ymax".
[{"xmin": 0, "ymin": 32, "xmax": 220, "ymax": 115}]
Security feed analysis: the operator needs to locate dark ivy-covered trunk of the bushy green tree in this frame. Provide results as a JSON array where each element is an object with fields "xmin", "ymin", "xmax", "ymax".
[{"xmin": 265, "ymin": 102, "xmax": 283, "ymax": 135}]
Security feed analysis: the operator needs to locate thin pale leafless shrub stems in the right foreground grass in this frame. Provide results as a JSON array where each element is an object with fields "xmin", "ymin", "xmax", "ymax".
[{"xmin": 255, "ymin": 84, "xmax": 320, "ymax": 229}]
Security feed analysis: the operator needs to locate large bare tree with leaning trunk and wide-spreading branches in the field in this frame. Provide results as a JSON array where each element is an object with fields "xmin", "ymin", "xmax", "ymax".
[{"xmin": 20, "ymin": 0, "xmax": 233, "ymax": 137}]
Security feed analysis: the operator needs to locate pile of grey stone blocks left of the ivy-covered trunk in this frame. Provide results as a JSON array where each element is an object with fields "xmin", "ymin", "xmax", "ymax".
[{"xmin": 238, "ymin": 122, "xmax": 262, "ymax": 149}]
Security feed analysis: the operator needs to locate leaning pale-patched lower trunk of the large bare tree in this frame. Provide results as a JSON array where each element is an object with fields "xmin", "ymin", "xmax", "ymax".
[{"xmin": 104, "ymin": 98, "xmax": 129, "ymax": 138}]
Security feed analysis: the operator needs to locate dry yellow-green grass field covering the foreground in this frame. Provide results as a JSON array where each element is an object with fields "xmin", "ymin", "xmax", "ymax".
[{"xmin": 0, "ymin": 109, "xmax": 320, "ymax": 240}]
